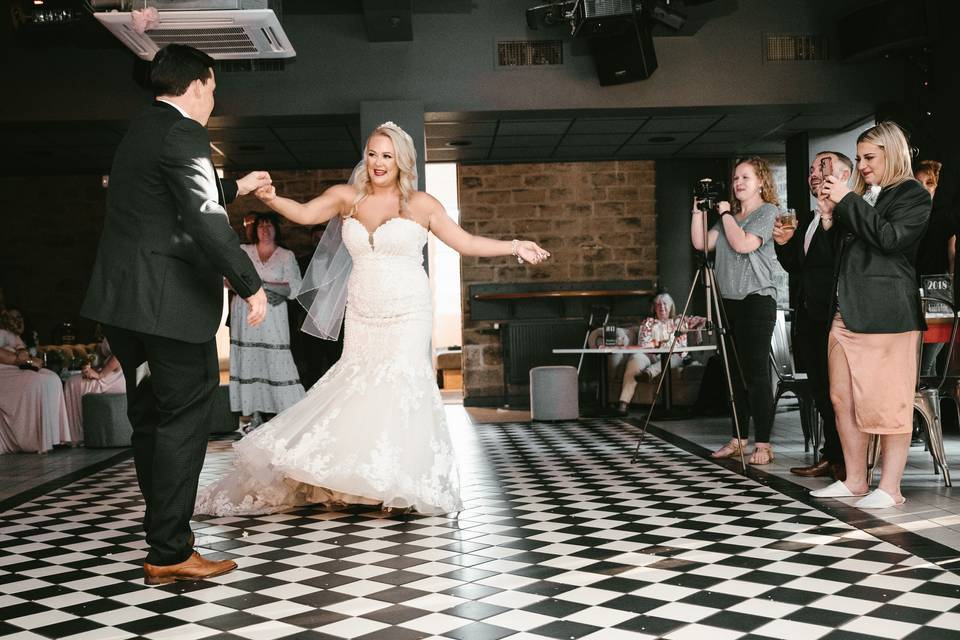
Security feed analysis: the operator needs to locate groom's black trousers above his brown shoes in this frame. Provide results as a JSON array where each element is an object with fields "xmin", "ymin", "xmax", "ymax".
[{"xmin": 104, "ymin": 326, "xmax": 220, "ymax": 565}]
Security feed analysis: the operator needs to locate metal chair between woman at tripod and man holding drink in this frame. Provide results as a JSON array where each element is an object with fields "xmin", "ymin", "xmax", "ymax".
[{"xmin": 770, "ymin": 309, "xmax": 823, "ymax": 463}]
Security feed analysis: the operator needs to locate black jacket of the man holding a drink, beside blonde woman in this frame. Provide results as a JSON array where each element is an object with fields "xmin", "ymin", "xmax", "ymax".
[{"xmin": 773, "ymin": 215, "xmax": 834, "ymax": 330}]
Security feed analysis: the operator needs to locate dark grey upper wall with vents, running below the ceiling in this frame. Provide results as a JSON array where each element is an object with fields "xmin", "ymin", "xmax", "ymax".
[{"xmin": 0, "ymin": 0, "xmax": 903, "ymax": 123}]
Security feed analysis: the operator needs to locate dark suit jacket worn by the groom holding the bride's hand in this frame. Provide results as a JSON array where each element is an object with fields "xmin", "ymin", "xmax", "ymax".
[{"xmin": 81, "ymin": 101, "xmax": 261, "ymax": 343}]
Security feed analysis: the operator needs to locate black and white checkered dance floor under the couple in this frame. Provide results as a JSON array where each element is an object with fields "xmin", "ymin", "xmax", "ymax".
[{"xmin": 0, "ymin": 421, "xmax": 960, "ymax": 640}]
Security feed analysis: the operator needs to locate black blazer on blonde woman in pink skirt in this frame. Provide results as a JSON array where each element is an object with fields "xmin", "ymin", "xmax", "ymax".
[{"xmin": 829, "ymin": 179, "xmax": 930, "ymax": 333}]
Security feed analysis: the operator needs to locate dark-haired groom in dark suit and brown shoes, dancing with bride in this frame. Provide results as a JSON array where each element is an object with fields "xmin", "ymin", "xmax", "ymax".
[{"xmin": 81, "ymin": 45, "xmax": 270, "ymax": 584}]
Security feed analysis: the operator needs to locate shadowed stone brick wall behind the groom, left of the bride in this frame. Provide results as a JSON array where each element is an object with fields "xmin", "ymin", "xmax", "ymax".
[{"xmin": 0, "ymin": 169, "xmax": 350, "ymax": 342}]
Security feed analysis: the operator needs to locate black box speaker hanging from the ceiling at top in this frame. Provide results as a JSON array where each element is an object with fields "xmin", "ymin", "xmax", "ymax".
[{"xmin": 589, "ymin": 11, "xmax": 657, "ymax": 86}]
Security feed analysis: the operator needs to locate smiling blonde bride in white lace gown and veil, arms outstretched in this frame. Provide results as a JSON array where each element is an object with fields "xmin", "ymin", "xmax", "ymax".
[{"xmin": 196, "ymin": 122, "xmax": 550, "ymax": 515}]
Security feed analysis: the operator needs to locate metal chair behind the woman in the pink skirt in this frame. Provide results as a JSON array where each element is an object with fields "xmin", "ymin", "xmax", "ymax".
[{"xmin": 867, "ymin": 296, "xmax": 960, "ymax": 487}]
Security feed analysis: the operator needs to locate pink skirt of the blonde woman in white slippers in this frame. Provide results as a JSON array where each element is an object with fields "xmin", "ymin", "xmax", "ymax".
[{"xmin": 827, "ymin": 314, "xmax": 920, "ymax": 435}]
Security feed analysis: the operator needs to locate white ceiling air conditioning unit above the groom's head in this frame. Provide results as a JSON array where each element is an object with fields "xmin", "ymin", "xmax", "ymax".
[{"xmin": 93, "ymin": 9, "xmax": 297, "ymax": 60}]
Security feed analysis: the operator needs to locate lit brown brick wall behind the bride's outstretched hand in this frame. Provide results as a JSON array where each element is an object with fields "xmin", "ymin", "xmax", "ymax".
[{"xmin": 460, "ymin": 161, "xmax": 657, "ymax": 403}]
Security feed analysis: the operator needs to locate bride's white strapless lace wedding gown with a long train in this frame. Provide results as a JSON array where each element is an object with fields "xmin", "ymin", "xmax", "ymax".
[{"xmin": 196, "ymin": 217, "xmax": 461, "ymax": 515}]
